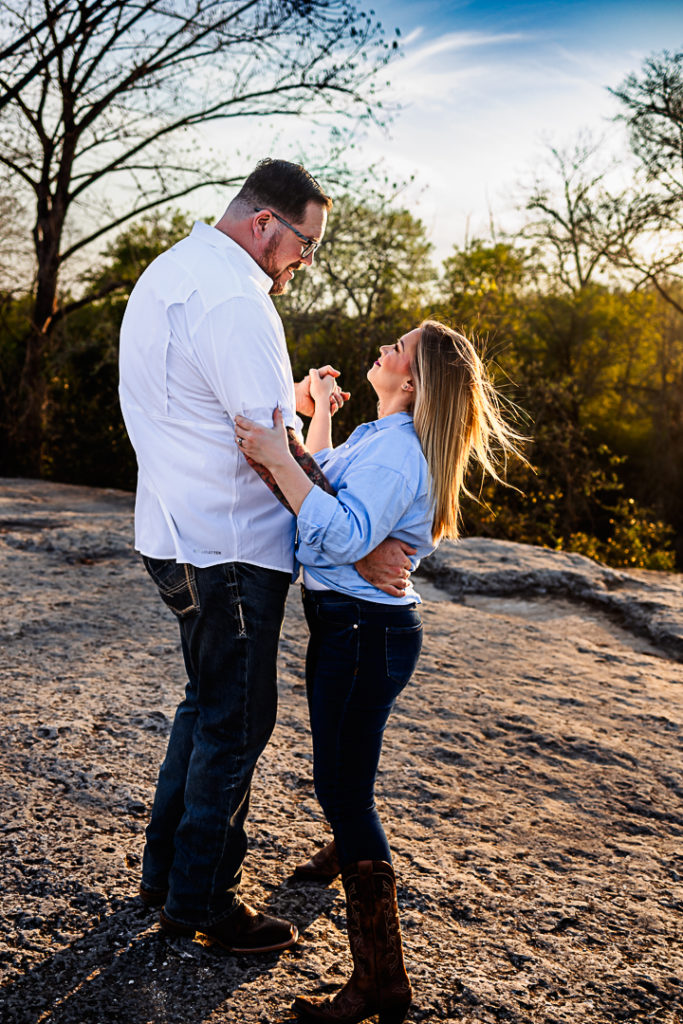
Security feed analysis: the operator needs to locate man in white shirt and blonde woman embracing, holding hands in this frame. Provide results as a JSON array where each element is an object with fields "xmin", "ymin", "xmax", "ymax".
[{"xmin": 120, "ymin": 160, "xmax": 516, "ymax": 1024}]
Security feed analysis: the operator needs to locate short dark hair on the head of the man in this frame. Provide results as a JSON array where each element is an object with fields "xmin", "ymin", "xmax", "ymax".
[{"xmin": 233, "ymin": 157, "xmax": 332, "ymax": 222}]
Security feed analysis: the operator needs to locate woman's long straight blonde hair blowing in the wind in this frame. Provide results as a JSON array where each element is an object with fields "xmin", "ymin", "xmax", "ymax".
[{"xmin": 412, "ymin": 319, "xmax": 525, "ymax": 541}]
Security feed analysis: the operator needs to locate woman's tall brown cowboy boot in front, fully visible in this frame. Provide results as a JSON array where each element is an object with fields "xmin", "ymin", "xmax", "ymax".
[{"xmin": 294, "ymin": 860, "xmax": 413, "ymax": 1024}]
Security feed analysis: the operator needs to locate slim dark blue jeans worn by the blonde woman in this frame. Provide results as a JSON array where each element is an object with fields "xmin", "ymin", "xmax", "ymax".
[{"xmin": 303, "ymin": 590, "xmax": 422, "ymax": 867}]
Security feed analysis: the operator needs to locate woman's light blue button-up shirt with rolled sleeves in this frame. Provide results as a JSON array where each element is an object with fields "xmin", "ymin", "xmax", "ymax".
[{"xmin": 297, "ymin": 413, "xmax": 434, "ymax": 604}]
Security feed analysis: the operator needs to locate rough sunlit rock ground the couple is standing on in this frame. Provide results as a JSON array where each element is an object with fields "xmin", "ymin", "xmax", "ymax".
[{"xmin": 0, "ymin": 480, "xmax": 683, "ymax": 1024}]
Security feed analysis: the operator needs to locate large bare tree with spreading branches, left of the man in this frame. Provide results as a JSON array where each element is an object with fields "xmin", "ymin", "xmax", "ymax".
[{"xmin": 0, "ymin": 0, "xmax": 396, "ymax": 471}]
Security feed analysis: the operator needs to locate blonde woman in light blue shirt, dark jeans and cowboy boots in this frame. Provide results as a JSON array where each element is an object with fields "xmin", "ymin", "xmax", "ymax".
[{"xmin": 236, "ymin": 321, "xmax": 519, "ymax": 1024}]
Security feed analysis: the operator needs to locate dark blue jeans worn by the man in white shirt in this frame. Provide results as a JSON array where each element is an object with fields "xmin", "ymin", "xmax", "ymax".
[{"xmin": 142, "ymin": 558, "xmax": 291, "ymax": 925}]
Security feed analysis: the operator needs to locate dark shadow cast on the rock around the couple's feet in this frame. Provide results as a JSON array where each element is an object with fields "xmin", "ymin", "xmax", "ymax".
[{"xmin": 0, "ymin": 883, "xmax": 338, "ymax": 1024}]
